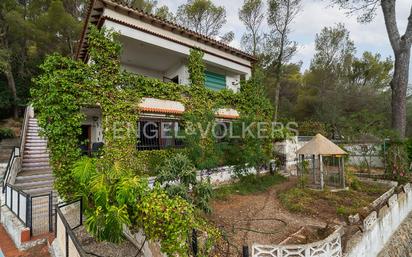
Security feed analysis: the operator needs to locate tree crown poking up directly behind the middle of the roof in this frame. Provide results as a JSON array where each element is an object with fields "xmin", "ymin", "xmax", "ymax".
[{"xmin": 176, "ymin": 0, "xmax": 226, "ymax": 37}]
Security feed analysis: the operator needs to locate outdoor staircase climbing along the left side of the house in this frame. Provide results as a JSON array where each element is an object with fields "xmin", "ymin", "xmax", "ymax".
[{"xmin": 14, "ymin": 118, "xmax": 57, "ymax": 199}]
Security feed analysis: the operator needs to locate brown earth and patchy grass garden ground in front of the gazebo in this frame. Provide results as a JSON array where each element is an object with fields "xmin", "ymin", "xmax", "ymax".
[{"xmin": 206, "ymin": 171, "xmax": 390, "ymax": 256}]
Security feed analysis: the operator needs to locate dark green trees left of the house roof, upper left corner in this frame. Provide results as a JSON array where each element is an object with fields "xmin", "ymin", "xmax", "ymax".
[{"xmin": 0, "ymin": 0, "xmax": 85, "ymax": 118}]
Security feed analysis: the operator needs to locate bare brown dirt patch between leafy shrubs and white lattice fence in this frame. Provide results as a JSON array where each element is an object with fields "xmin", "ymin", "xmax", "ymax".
[{"xmin": 209, "ymin": 178, "xmax": 326, "ymax": 256}]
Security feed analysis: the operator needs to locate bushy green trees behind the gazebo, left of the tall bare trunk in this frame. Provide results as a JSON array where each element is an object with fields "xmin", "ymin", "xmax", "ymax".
[{"xmin": 292, "ymin": 24, "xmax": 393, "ymax": 138}]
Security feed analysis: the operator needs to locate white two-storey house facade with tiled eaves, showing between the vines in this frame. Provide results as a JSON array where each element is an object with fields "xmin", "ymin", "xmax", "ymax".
[{"xmin": 77, "ymin": 0, "xmax": 255, "ymax": 152}]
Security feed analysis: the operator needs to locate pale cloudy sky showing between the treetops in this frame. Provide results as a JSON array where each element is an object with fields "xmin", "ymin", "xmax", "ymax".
[{"xmin": 158, "ymin": 0, "xmax": 412, "ymax": 78}]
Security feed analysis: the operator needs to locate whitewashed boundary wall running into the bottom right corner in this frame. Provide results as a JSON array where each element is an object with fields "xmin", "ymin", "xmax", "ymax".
[{"xmin": 344, "ymin": 183, "xmax": 412, "ymax": 257}]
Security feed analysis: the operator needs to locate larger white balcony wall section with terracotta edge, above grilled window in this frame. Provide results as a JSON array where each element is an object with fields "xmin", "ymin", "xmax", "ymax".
[{"xmin": 139, "ymin": 97, "xmax": 185, "ymax": 114}]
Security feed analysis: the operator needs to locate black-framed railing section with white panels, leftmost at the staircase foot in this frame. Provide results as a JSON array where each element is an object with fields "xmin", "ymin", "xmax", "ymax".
[{"xmin": 5, "ymin": 184, "xmax": 31, "ymax": 226}]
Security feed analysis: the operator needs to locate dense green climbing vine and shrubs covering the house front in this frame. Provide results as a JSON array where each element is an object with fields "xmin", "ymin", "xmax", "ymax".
[{"xmin": 31, "ymin": 27, "xmax": 284, "ymax": 256}]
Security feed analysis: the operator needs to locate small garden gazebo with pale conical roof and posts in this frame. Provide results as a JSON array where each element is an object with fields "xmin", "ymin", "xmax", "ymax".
[{"xmin": 296, "ymin": 134, "xmax": 347, "ymax": 190}]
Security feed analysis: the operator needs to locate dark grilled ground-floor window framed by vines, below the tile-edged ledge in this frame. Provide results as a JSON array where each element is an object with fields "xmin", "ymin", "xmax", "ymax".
[{"xmin": 137, "ymin": 119, "xmax": 183, "ymax": 150}]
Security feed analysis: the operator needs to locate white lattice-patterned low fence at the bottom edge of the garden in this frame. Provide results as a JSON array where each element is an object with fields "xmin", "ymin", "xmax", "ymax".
[{"xmin": 252, "ymin": 227, "xmax": 342, "ymax": 257}]
